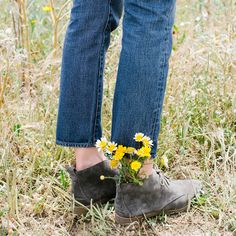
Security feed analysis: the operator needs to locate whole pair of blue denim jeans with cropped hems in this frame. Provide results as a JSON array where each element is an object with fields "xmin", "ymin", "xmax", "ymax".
[{"xmin": 56, "ymin": 0, "xmax": 176, "ymax": 157}]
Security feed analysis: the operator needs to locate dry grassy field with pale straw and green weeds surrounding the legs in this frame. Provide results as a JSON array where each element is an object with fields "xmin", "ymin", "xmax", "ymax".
[{"xmin": 0, "ymin": 0, "xmax": 236, "ymax": 236}]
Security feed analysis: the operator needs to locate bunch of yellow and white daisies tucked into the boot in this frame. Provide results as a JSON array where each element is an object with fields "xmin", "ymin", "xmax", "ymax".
[{"xmin": 96, "ymin": 132, "xmax": 153, "ymax": 185}]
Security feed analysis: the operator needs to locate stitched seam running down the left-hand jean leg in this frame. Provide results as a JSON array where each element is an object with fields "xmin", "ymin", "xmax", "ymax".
[{"xmin": 93, "ymin": 0, "xmax": 111, "ymax": 143}]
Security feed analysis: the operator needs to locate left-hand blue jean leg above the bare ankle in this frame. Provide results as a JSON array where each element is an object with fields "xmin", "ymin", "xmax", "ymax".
[{"xmin": 56, "ymin": 0, "xmax": 123, "ymax": 147}]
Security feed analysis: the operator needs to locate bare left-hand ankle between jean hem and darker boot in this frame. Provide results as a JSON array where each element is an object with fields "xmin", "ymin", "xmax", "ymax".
[{"xmin": 75, "ymin": 147, "xmax": 106, "ymax": 171}]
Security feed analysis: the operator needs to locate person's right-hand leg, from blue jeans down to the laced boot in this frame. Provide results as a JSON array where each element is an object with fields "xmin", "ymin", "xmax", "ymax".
[{"xmin": 112, "ymin": 0, "xmax": 201, "ymax": 224}]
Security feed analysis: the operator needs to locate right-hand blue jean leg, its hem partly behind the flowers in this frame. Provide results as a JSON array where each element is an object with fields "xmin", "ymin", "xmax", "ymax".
[{"xmin": 111, "ymin": 0, "xmax": 176, "ymax": 157}]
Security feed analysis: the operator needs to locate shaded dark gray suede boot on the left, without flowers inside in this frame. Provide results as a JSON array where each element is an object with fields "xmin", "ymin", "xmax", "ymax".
[{"xmin": 66, "ymin": 161, "xmax": 117, "ymax": 215}]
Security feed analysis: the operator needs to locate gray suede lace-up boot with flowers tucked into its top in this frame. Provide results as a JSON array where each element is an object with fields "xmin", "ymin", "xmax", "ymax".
[{"xmin": 115, "ymin": 171, "xmax": 201, "ymax": 224}]
